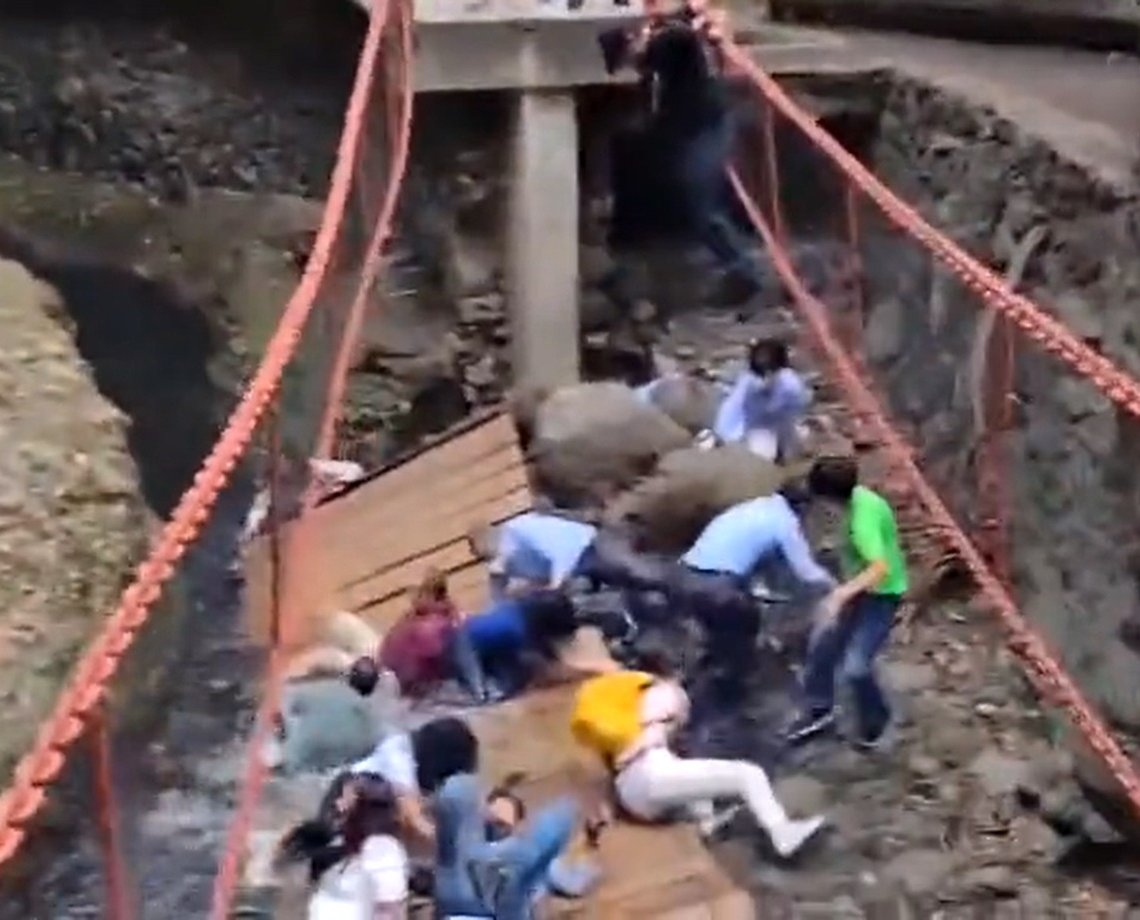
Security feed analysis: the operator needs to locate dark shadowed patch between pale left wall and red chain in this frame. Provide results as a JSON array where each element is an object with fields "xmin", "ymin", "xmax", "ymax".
[{"xmin": 0, "ymin": 229, "xmax": 227, "ymax": 518}]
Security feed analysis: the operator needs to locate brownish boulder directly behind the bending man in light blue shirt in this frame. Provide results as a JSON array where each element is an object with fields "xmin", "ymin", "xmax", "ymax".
[{"xmin": 605, "ymin": 445, "xmax": 792, "ymax": 554}]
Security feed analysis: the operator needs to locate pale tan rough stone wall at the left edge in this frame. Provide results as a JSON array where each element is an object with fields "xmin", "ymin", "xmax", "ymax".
[{"xmin": 0, "ymin": 261, "xmax": 147, "ymax": 785}]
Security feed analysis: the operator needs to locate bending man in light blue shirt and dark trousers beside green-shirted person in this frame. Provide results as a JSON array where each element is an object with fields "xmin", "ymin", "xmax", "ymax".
[{"xmin": 673, "ymin": 481, "xmax": 834, "ymax": 701}]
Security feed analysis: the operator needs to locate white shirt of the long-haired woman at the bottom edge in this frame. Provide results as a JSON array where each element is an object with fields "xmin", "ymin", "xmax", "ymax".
[{"xmin": 309, "ymin": 836, "xmax": 408, "ymax": 920}]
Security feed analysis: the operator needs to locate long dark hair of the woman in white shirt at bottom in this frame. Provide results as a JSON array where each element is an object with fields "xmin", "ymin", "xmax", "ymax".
[{"xmin": 277, "ymin": 773, "xmax": 400, "ymax": 881}]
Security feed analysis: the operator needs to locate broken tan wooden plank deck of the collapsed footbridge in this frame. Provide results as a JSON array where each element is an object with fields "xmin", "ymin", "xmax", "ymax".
[{"xmin": 249, "ymin": 415, "xmax": 757, "ymax": 920}]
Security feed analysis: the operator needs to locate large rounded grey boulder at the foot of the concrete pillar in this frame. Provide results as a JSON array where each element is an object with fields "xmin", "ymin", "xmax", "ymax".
[{"xmin": 528, "ymin": 383, "xmax": 691, "ymax": 507}]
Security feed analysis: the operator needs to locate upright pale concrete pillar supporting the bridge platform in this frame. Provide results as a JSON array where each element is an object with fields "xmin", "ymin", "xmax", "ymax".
[{"xmin": 506, "ymin": 89, "xmax": 579, "ymax": 386}]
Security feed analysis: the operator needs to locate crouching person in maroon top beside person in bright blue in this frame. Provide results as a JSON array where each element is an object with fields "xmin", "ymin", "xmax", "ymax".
[{"xmin": 378, "ymin": 569, "xmax": 466, "ymax": 697}]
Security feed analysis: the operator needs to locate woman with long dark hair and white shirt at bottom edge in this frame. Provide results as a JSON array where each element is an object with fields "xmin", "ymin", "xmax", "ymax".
[{"xmin": 277, "ymin": 774, "xmax": 409, "ymax": 920}]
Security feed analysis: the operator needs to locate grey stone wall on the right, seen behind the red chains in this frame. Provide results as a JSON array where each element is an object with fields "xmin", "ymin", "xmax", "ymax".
[{"xmin": 864, "ymin": 75, "xmax": 1140, "ymax": 726}]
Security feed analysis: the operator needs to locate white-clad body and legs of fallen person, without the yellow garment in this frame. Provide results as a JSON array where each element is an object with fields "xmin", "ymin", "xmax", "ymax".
[{"xmin": 614, "ymin": 666, "xmax": 824, "ymax": 858}]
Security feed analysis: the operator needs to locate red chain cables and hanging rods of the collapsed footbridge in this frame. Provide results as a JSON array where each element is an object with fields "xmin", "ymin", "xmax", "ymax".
[{"xmin": 0, "ymin": 0, "xmax": 1140, "ymax": 920}]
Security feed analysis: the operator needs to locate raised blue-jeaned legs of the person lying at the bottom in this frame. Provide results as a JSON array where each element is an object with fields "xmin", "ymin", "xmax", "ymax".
[{"xmin": 434, "ymin": 773, "xmax": 578, "ymax": 920}]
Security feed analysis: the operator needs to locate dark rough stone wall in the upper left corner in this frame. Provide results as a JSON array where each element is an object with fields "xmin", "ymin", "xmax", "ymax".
[{"xmin": 0, "ymin": 9, "xmax": 356, "ymax": 200}]
